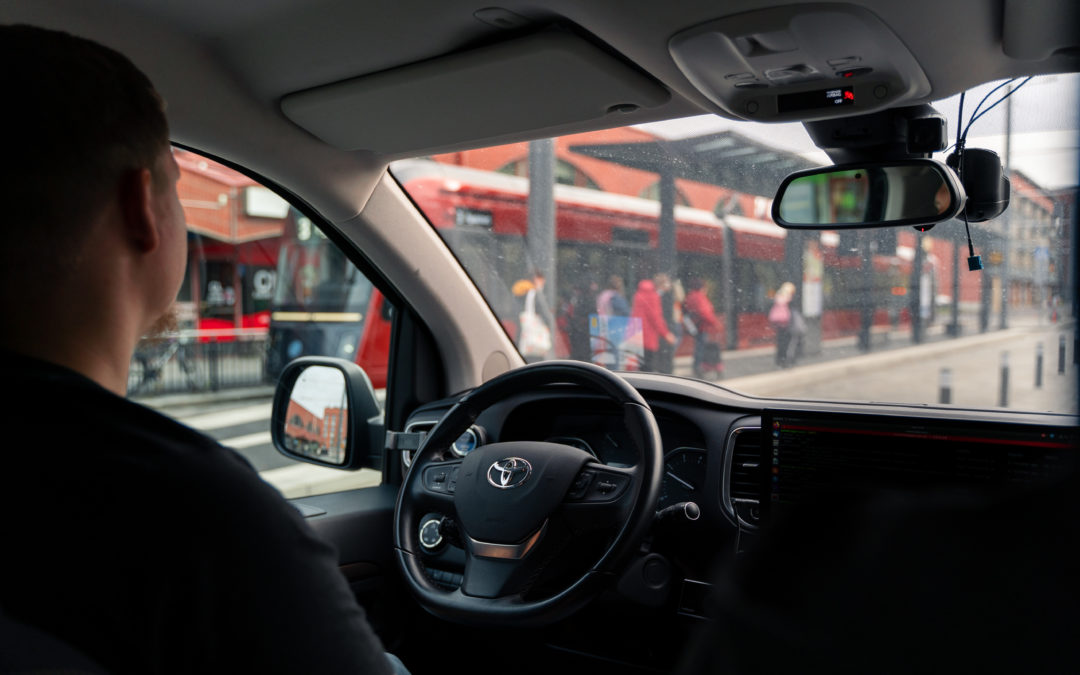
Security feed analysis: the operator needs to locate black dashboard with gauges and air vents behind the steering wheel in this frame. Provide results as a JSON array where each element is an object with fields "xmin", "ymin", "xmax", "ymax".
[{"xmin": 402, "ymin": 375, "xmax": 1080, "ymax": 617}]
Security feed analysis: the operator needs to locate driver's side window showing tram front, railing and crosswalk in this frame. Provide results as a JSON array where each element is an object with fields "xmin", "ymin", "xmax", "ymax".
[{"xmin": 127, "ymin": 149, "xmax": 393, "ymax": 497}]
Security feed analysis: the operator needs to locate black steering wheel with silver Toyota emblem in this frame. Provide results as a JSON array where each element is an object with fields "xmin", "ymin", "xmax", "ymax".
[{"xmin": 394, "ymin": 361, "xmax": 663, "ymax": 625}]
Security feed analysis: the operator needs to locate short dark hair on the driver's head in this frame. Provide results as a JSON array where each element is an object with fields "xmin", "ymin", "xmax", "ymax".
[{"xmin": 0, "ymin": 25, "xmax": 168, "ymax": 260}]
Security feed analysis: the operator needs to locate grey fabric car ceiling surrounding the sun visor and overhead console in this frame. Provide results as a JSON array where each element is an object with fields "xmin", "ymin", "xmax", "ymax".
[{"xmin": 0, "ymin": 0, "xmax": 1078, "ymax": 219}]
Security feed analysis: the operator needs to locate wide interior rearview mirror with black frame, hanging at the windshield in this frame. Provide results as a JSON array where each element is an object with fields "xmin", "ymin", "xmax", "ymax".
[{"xmin": 772, "ymin": 160, "xmax": 966, "ymax": 230}]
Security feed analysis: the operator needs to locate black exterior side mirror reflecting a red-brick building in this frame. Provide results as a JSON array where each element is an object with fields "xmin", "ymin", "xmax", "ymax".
[{"xmin": 270, "ymin": 356, "xmax": 383, "ymax": 471}]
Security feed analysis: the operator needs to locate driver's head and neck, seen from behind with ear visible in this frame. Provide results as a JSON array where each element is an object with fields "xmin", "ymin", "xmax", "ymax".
[{"xmin": 0, "ymin": 26, "xmax": 187, "ymax": 391}]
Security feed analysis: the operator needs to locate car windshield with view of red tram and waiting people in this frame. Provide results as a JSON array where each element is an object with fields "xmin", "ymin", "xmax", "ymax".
[{"xmin": 391, "ymin": 76, "xmax": 1078, "ymax": 414}]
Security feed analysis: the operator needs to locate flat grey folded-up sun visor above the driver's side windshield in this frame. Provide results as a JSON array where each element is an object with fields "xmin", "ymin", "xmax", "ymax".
[{"xmin": 282, "ymin": 31, "xmax": 671, "ymax": 154}]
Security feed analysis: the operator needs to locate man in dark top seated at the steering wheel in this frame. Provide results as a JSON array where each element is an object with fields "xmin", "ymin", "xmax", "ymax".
[{"xmin": 0, "ymin": 26, "xmax": 401, "ymax": 673}]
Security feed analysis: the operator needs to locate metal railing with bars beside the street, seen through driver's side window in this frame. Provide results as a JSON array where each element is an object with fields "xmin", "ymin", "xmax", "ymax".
[{"xmin": 127, "ymin": 329, "xmax": 269, "ymax": 396}]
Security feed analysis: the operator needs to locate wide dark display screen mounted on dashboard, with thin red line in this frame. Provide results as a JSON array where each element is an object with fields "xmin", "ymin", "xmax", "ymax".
[{"xmin": 761, "ymin": 410, "xmax": 1077, "ymax": 517}]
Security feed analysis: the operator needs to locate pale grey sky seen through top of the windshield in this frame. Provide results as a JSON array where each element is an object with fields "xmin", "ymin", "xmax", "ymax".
[{"xmin": 640, "ymin": 73, "xmax": 1080, "ymax": 189}]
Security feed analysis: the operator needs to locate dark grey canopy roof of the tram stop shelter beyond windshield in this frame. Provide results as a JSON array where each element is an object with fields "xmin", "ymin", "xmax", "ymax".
[{"xmin": 570, "ymin": 131, "xmax": 818, "ymax": 197}]
